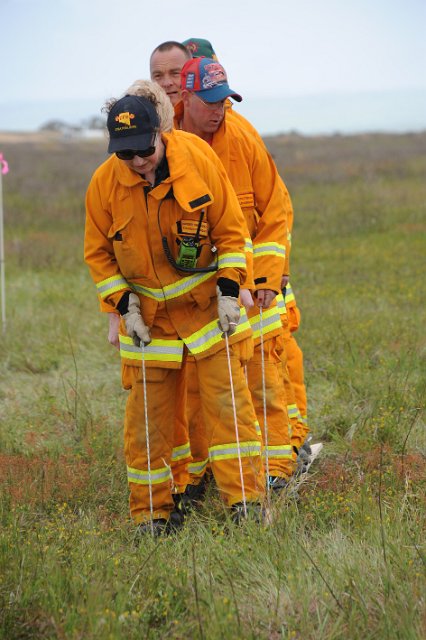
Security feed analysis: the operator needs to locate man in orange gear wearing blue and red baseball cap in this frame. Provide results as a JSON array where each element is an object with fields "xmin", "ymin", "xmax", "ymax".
[{"xmin": 175, "ymin": 58, "xmax": 293, "ymax": 488}]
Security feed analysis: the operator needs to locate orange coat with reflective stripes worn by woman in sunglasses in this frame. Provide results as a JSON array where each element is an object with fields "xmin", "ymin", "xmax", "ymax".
[{"xmin": 85, "ymin": 131, "xmax": 255, "ymax": 368}]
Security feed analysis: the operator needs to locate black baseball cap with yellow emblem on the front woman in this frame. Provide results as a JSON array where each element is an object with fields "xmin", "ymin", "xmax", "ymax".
[{"xmin": 107, "ymin": 96, "xmax": 160, "ymax": 153}]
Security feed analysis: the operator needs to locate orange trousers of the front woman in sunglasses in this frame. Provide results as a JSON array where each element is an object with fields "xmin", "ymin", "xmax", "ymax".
[{"xmin": 124, "ymin": 339, "xmax": 265, "ymax": 523}]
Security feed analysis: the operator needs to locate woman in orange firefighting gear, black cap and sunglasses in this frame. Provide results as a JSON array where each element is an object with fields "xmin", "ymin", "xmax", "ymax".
[{"xmin": 85, "ymin": 87, "xmax": 264, "ymax": 533}]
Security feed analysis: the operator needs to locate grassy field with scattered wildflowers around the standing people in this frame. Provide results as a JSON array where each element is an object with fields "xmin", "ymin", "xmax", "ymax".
[{"xmin": 0, "ymin": 134, "xmax": 426, "ymax": 640}]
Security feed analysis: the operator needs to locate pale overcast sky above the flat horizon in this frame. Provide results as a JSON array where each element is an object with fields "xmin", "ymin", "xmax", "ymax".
[{"xmin": 0, "ymin": 0, "xmax": 426, "ymax": 130}]
